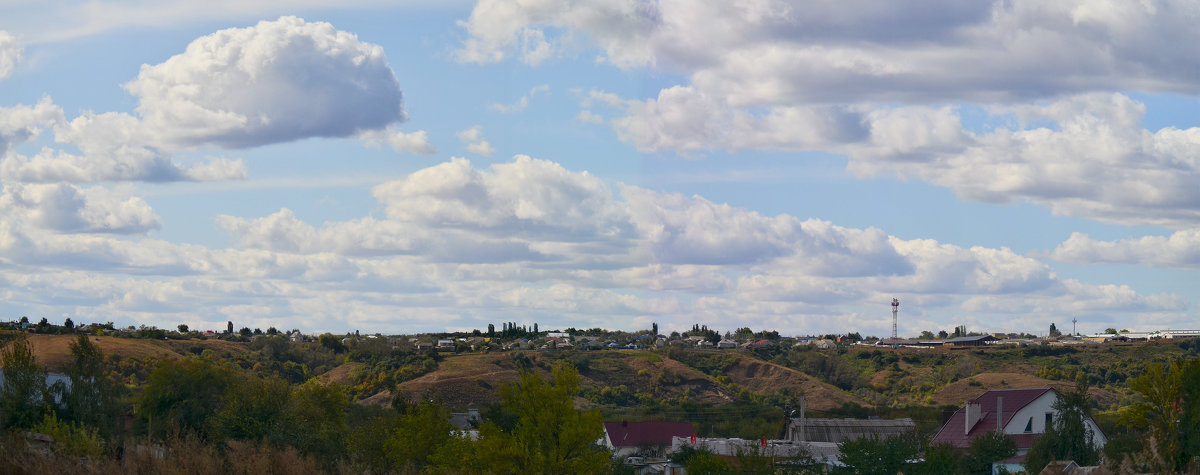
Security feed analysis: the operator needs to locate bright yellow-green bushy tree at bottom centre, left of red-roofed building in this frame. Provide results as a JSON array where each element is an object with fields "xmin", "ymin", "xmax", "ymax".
[{"xmin": 476, "ymin": 363, "xmax": 608, "ymax": 474}]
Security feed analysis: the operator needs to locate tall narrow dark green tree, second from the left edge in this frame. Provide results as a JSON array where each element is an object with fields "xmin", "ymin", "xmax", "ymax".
[{"xmin": 55, "ymin": 335, "xmax": 124, "ymax": 437}]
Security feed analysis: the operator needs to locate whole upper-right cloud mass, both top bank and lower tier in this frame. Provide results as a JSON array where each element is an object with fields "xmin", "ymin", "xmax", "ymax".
[{"xmin": 460, "ymin": 0, "xmax": 1200, "ymax": 228}]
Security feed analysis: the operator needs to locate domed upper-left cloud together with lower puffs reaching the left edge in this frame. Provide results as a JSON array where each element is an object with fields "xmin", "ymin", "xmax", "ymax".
[{"xmin": 0, "ymin": 17, "xmax": 436, "ymax": 182}]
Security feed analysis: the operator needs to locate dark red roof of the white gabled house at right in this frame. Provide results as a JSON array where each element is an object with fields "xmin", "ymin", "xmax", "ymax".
[{"xmin": 930, "ymin": 387, "xmax": 1054, "ymax": 449}]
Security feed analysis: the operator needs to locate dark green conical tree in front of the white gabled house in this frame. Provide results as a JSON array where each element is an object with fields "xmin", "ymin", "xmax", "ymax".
[{"xmin": 1025, "ymin": 380, "xmax": 1100, "ymax": 474}]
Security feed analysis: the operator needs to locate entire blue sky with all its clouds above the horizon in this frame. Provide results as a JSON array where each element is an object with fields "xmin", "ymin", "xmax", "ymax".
[{"xmin": 0, "ymin": 0, "xmax": 1200, "ymax": 337}]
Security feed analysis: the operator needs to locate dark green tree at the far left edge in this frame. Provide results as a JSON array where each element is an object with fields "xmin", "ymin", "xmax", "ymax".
[{"xmin": 0, "ymin": 338, "xmax": 54, "ymax": 429}]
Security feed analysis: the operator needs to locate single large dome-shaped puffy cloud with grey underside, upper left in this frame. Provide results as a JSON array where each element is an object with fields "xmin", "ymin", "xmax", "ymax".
[{"xmin": 125, "ymin": 17, "xmax": 404, "ymax": 148}]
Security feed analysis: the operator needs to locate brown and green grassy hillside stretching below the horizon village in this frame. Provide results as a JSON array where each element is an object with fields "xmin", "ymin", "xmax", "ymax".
[{"xmin": 14, "ymin": 335, "xmax": 1200, "ymax": 411}]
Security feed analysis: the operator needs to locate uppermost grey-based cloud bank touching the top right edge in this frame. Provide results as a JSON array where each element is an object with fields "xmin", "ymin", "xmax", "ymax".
[{"xmin": 460, "ymin": 0, "xmax": 1200, "ymax": 101}]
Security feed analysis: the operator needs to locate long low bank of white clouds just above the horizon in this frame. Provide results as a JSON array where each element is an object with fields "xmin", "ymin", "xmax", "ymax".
[{"xmin": 0, "ymin": 156, "xmax": 1186, "ymax": 331}]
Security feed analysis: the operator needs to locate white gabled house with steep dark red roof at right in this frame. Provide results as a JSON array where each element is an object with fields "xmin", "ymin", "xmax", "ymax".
[{"xmin": 931, "ymin": 387, "xmax": 1108, "ymax": 473}]
